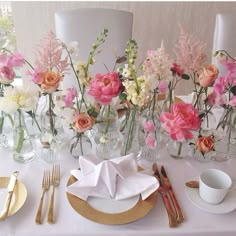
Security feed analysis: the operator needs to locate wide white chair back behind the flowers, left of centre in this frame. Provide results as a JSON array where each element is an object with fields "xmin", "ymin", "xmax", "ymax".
[{"xmin": 55, "ymin": 8, "xmax": 133, "ymax": 88}]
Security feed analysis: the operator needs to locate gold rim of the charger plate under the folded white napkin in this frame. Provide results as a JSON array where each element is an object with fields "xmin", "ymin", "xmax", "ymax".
[{"xmin": 66, "ymin": 176, "xmax": 157, "ymax": 225}]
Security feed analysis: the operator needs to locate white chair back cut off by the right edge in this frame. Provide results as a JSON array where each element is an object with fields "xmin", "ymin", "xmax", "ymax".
[{"xmin": 213, "ymin": 13, "xmax": 236, "ymax": 76}]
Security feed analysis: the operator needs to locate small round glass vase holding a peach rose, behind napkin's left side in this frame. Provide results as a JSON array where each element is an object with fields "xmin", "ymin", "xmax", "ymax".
[{"xmin": 69, "ymin": 133, "xmax": 92, "ymax": 159}]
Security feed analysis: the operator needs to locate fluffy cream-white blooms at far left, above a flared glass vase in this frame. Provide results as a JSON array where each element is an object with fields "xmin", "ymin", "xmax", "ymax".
[{"xmin": 0, "ymin": 86, "xmax": 39, "ymax": 113}]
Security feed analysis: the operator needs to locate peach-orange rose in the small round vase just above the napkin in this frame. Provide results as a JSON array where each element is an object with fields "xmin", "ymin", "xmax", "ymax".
[{"xmin": 72, "ymin": 112, "xmax": 95, "ymax": 133}]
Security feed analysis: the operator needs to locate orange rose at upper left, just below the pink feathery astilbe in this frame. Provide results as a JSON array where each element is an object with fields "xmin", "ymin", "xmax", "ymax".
[{"xmin": 41, "ymin": 71, "xmax": 62, "ymax": 93}]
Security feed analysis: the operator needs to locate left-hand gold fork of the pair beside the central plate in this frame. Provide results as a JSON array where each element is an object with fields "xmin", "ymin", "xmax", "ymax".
[{"xmin": 35, "ymin": 170, "xmax": 50, "ymax": 224}]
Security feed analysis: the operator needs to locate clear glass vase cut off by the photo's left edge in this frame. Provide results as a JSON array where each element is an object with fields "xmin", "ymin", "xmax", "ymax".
[{"xmin": 0, "ymin": 111, "xmax": 14, "ymax": 148}]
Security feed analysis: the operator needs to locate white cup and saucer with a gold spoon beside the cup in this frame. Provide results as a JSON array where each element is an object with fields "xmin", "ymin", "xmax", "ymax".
[{"xmin": 185, "ymin": 169, "xmax": 236, "ymax": 214}]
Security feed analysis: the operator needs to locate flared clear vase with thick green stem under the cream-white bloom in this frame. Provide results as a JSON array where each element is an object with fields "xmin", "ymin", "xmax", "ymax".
[{"xmin": 13, "ymin": 110, "xmax": 35, "ymax": 163}]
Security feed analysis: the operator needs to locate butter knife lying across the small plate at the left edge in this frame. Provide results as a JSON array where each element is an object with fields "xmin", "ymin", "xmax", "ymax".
[{"xmin": 0, "ymin": 171, "xmax": 19, "ymax": 221}]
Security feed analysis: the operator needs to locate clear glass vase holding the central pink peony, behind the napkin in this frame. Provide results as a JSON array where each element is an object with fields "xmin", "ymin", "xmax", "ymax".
[{"xmin": 93, "ymin": 104, "xmax": 122, "ymax": 159}]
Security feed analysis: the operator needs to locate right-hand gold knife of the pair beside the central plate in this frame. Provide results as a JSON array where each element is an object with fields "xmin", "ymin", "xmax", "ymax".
[{"xmin": 161, "ymin": 166, "xmax": 184, "ymax": 223}]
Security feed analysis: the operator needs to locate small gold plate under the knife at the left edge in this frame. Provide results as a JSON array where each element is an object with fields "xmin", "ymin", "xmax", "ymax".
[{"xmin": 0, "ymin": 177, "xmax": 27, "ymax": 216}]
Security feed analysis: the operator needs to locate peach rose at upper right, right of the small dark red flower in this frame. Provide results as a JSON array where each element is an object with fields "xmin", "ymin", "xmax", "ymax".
[{"xmin": 198, "ymin": 65, "xmax": 219, "ymax": 88}]
